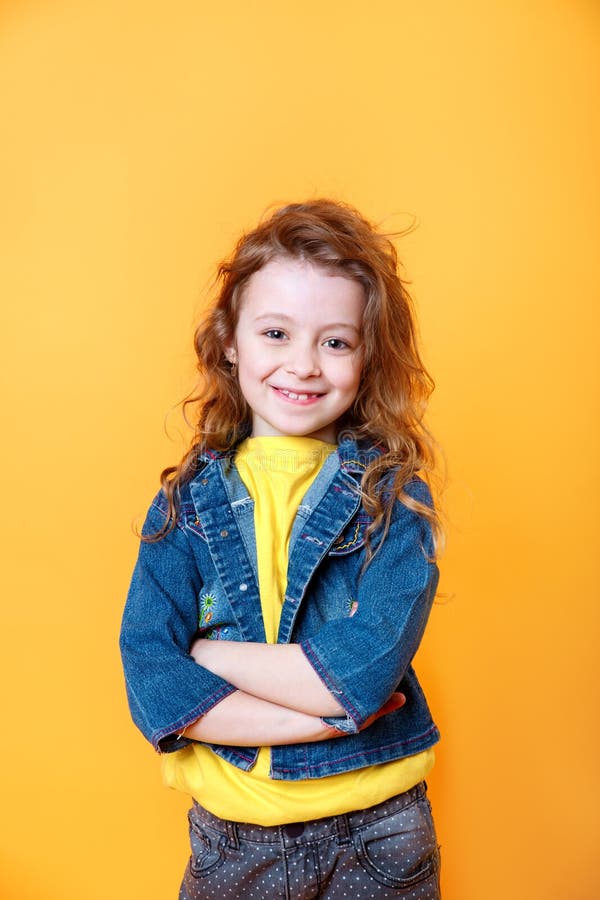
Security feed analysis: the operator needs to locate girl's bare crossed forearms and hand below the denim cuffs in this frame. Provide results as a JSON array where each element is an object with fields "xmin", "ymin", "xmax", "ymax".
[{"xmin": 180, "ymin": 639, "xmax": 404, "ymax": 746}]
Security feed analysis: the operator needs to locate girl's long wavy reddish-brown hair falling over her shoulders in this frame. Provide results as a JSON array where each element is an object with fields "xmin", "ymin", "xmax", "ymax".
[{"xmin": 145, "ymin": 199, "xmax": 441, "ymax": 543}]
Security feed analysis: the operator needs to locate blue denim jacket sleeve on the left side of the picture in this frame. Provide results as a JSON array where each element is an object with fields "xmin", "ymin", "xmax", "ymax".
[{"xmin": 120, "ymin": 495, "xmax": 235, "ymax": 752}]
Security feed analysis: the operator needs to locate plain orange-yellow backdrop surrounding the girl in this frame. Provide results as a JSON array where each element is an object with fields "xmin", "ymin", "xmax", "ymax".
[{"xmin": 0, "ymin": 0, "xmax": 600, "ymax": 900}]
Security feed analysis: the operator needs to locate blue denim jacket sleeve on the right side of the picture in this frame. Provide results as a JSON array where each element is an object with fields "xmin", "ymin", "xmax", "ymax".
[{"xmin": 300, "ymin": 482, "xmax": 438, "ymax": 733}]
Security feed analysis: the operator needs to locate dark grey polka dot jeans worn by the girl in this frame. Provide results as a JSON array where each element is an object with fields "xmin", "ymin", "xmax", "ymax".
[{"xmin": 179, "ymin": 782, "xmax": 440, "ymax": 900}]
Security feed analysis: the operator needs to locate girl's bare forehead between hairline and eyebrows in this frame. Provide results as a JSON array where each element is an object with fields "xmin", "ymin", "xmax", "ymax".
[{"xmin": 240, "ymin": 258, "xmax": 365, "ymax": 327}]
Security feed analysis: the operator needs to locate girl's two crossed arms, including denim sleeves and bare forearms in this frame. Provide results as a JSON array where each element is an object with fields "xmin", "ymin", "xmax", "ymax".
[{"xmin": 120, "ymin": 488, "xmax": 437, "ymax": 752}]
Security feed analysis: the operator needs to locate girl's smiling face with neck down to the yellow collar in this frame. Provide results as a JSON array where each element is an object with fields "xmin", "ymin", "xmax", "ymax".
[{"xmin": 226, "ymin": 257, "xmax": 365, "ymax": 443}]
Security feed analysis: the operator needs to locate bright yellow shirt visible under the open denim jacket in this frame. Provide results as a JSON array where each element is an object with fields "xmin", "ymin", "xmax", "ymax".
[{"xmin": 163, "ymin": 437, "xmax": 434, "ymax": 825}]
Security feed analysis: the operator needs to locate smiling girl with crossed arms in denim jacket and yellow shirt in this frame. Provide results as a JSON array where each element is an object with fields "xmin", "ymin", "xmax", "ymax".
[{"xmin": 121, "ymin": 200, "xmax": 439, "ymax": 900}]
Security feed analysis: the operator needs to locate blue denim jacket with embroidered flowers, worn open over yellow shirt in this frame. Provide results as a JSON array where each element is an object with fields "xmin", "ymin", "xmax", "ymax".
[{"xmin": 121, "ymin": 440, "xmax": 439, "ymax": 780}]
